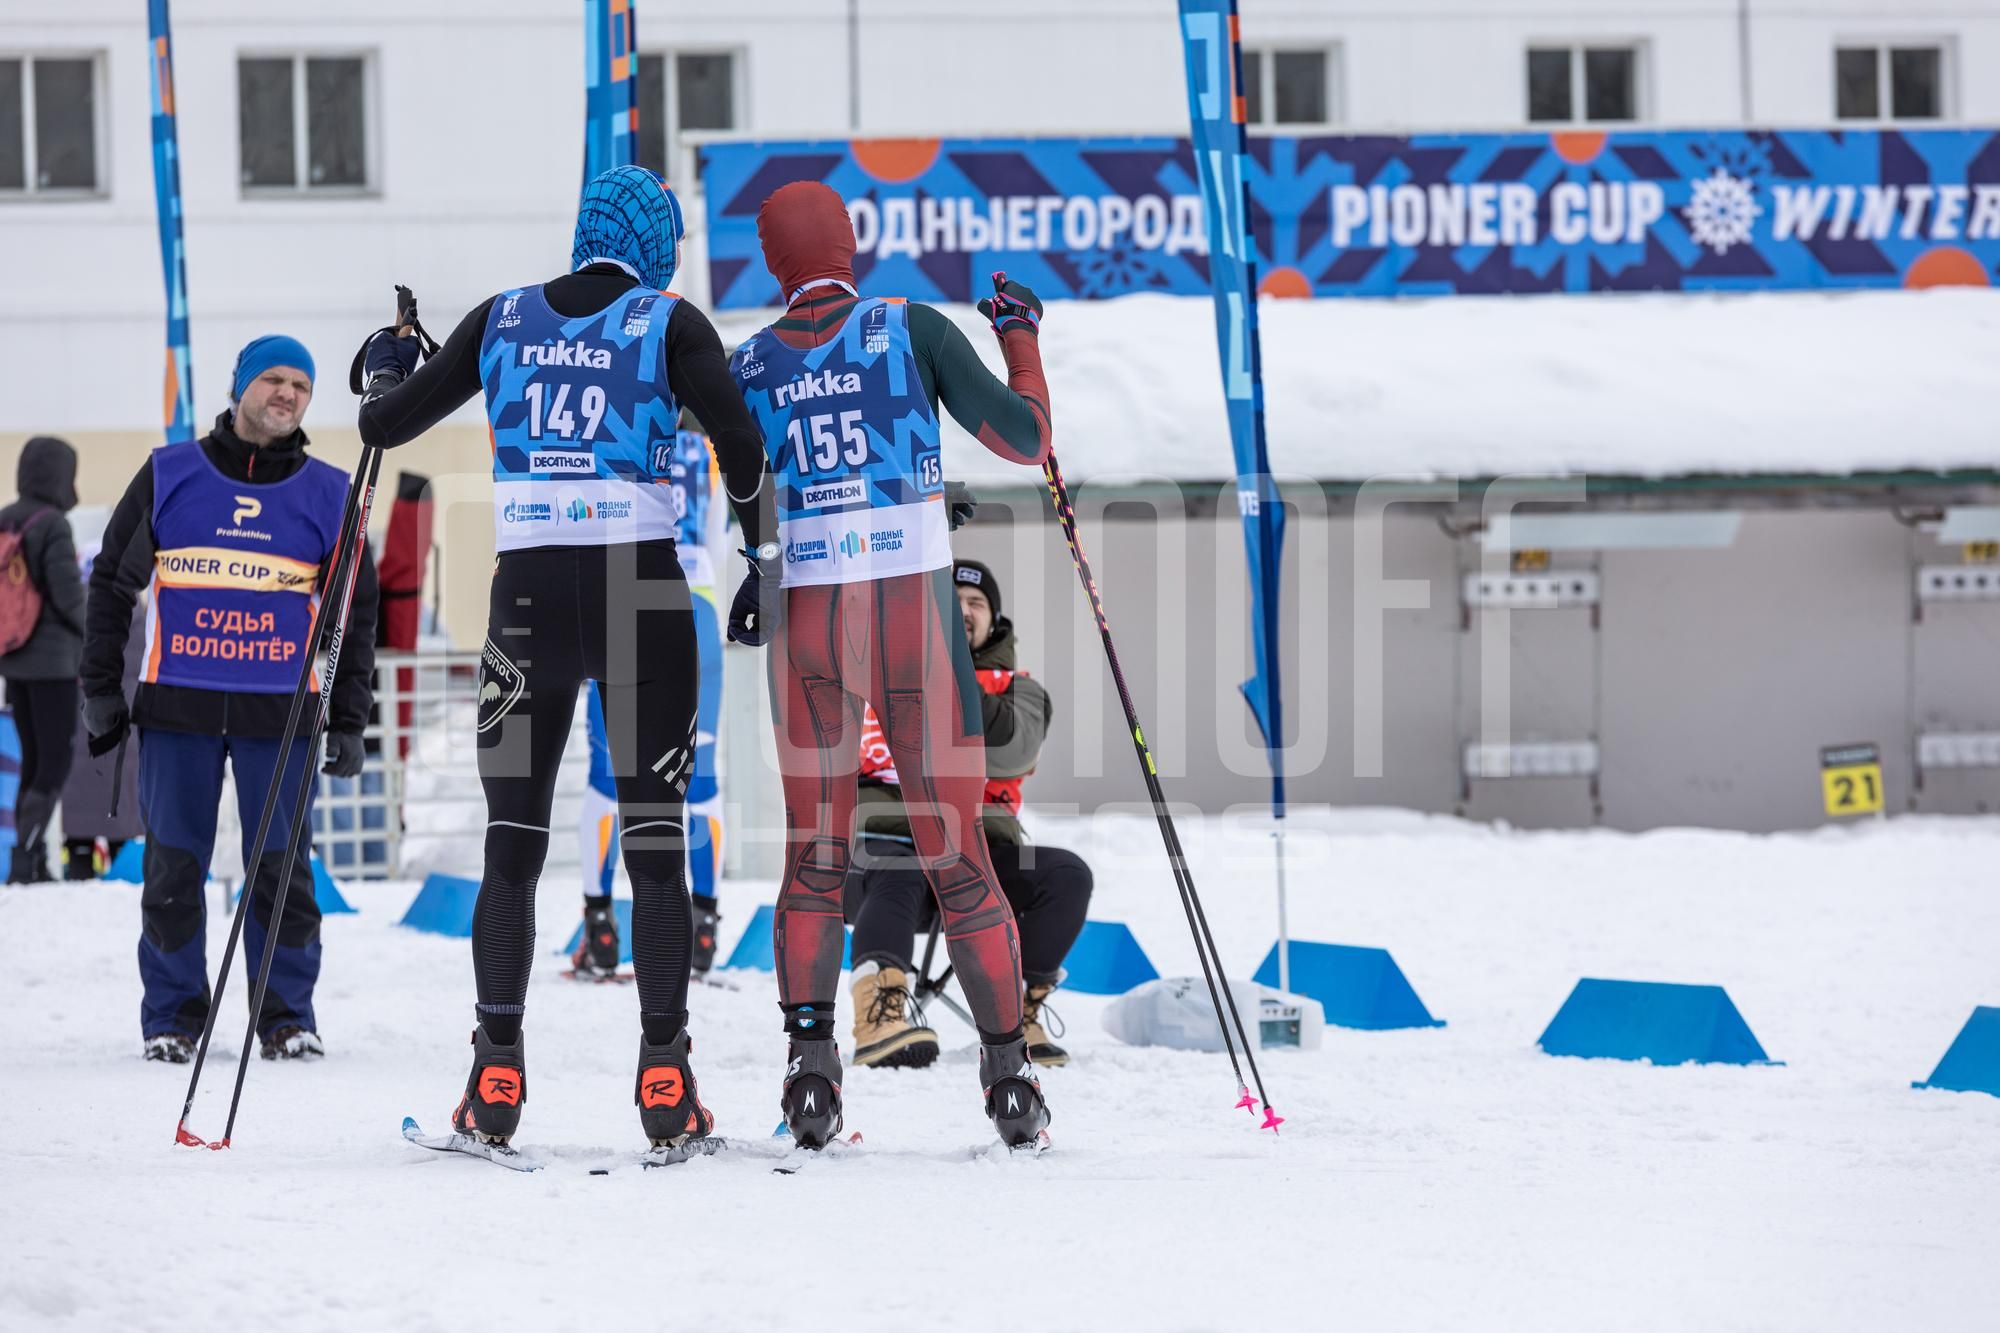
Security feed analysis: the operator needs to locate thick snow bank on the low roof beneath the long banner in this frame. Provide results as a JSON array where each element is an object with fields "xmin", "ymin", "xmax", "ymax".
[{"xmin": 720, "ymin": 288, "xmax": 2000, "ymax": 482}]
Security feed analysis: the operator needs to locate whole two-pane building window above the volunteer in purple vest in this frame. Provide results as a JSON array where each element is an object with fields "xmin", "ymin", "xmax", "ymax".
[{"xmin": 236, "ymin": 56, "xmax": 374, "ymax": 194}]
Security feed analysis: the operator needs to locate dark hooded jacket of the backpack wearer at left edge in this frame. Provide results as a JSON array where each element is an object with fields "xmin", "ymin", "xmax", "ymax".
[{"xmin": 0, "ymin": 434, "xmax": 84, "ymax": 681}]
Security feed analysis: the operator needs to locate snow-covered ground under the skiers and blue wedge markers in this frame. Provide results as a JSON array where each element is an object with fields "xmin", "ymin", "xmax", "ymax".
[{"xmin": 0, "ymin": 813, "xmax": 2000, "ymax": 1333}]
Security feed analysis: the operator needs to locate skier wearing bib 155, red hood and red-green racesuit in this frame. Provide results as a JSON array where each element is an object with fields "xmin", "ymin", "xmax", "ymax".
[{"xmin": 730, "ymin": 180, "xmax": 1050, "ymax": 1147}]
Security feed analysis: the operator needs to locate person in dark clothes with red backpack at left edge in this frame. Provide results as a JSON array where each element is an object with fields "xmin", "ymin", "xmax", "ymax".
[{"xmin": 0, "ymin": 434, "xmax": 84, "ymax": 885}]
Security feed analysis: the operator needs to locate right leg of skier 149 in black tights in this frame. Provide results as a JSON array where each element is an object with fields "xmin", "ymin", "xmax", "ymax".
[{"xmin": 584, "ymin": 542, "xmax": 700, "ymax": 1045}]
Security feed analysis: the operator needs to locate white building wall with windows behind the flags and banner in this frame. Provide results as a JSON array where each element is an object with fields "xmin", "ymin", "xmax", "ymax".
[{"xmin": 0, "ymin": 0, "xmax": 2000, "ymax": 436}]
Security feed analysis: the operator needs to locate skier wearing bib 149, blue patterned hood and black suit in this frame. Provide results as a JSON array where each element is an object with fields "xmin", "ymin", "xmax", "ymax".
[{"xmin": 358, "ymin": 166, "xmax": 776, "ymax": 1155}]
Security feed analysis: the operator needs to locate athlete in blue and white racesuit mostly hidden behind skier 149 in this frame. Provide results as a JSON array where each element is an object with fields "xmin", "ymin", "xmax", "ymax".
[{"xmin": 570, "ymin": 430, "xmax": 722, "ymax": 979}]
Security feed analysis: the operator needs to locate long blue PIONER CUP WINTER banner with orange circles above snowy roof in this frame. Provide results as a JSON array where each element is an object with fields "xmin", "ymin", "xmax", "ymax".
[{"xmin": 702, "ymin": 127, "xmax": 2000, "ymax": 310}]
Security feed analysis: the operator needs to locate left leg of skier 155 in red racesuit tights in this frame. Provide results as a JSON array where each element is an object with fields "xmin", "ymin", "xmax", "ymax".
[{"xmin": 770, "ymin": 582, "xmax": 868, "ymax": 1020}]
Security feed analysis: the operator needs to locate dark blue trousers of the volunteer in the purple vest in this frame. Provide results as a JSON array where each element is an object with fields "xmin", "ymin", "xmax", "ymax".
[{"xmin": 138, "ymin": 727, "xmax": 320, "ymax": 1037}]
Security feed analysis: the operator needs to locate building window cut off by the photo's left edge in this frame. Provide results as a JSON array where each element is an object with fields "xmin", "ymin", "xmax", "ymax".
[{"xmin": 0, "ymin": 56, "xmax": 104, "ymax": 196}]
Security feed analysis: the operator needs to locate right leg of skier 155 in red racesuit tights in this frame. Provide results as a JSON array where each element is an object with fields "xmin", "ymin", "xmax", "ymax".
[{"xmin": 868, "ymin": 570, "xmax": 1022, "ymax": 1045}]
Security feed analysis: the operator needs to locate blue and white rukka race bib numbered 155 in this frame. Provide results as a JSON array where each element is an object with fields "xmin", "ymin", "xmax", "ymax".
[{"xmin": 730, "ymin": 298, "xmax": 952, "ymax": 586}]
